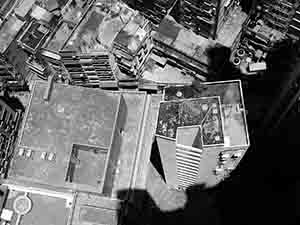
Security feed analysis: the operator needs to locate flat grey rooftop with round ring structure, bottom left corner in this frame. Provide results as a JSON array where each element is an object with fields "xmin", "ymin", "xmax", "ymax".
[{"xmin": 0, "ymin": 185, "xmax": 73, "ymax": 225}]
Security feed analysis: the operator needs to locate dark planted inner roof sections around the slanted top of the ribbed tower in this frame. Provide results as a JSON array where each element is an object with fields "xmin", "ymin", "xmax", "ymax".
[{"xmin": 156, "ymin": 97, "xmax": 224, "ymax": 147}]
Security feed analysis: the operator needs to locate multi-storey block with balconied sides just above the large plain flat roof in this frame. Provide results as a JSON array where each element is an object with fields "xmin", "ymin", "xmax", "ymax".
[{"xmin": 60, "ymin": 0, "xmax": 152, "ymax": 86}]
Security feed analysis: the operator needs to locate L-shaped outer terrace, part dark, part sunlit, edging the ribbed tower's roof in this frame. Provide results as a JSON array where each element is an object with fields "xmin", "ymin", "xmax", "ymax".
[{"xmin": 164, "ymin": 81, "xmax": 249, "ymax": 147}]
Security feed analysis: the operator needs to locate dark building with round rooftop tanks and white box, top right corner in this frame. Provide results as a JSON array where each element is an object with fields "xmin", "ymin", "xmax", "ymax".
[{"xmin": 231, "ymin": 0, "xmax": 299, "ymax": 75}]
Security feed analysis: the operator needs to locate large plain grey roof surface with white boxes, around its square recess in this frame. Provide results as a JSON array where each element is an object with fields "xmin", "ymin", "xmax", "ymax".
[{"xmin": 10, "ymin": 81, "xmax": 121, "ymax": 190}]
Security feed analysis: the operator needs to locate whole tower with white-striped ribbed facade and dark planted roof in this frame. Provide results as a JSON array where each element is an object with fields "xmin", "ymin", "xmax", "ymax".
[{"xmin": 156, "ymin": 81, "xmax": 249, "ymax": 188}]
